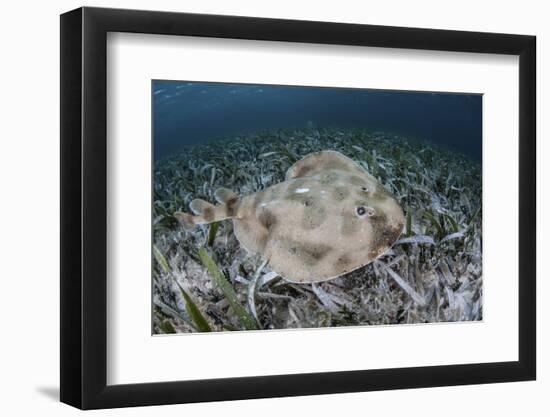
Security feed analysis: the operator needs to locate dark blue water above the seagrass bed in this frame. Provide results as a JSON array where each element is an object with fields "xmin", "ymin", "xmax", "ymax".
[{"xmin": 152, "ymin": 81, "xmax": 482, "ymax": 161}]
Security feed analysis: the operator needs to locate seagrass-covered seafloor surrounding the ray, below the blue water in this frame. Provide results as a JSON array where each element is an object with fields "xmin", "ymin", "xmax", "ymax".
[{"xmin": 152, "ymin": 128, "xmax": 483, "ymax": 334}]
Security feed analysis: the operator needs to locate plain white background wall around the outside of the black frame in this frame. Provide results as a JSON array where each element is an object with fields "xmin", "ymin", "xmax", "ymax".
[{"xmin": 0, "ymin": 0, "xmax": 550, "ymax": 416}]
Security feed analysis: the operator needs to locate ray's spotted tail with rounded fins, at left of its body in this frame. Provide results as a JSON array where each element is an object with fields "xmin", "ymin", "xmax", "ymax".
[{"xmin": 174, "ymin": 188, "xmax": 241, "ymax": 230}]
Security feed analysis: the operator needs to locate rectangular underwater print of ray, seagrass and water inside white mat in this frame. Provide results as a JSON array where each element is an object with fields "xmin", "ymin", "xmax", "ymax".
[{"xmin": 151, "ymin": 80, "xmax": 483, "ymax": 334}]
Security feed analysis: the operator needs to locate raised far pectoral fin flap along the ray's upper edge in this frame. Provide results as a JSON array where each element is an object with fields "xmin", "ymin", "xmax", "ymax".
[{"xmin": 286, "ymin": 151, "xmax": 366, "ymax": 180}]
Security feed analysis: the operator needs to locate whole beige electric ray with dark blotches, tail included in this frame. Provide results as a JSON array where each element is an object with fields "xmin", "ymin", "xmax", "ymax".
[{"xmin": 175, "ymin": 151, "xmax": 405, "ymax": 283}]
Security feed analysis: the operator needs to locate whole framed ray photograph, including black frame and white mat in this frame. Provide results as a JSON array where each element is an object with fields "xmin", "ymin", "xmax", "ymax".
[{"xmin": 60, "ymin": 7, "xmax": 536, "ymax": 409}]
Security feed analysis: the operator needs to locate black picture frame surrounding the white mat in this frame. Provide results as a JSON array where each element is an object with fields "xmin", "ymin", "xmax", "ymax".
[{"xmin": 60, "ymin": 7, "xmax": 536, "ymax": 409}]
